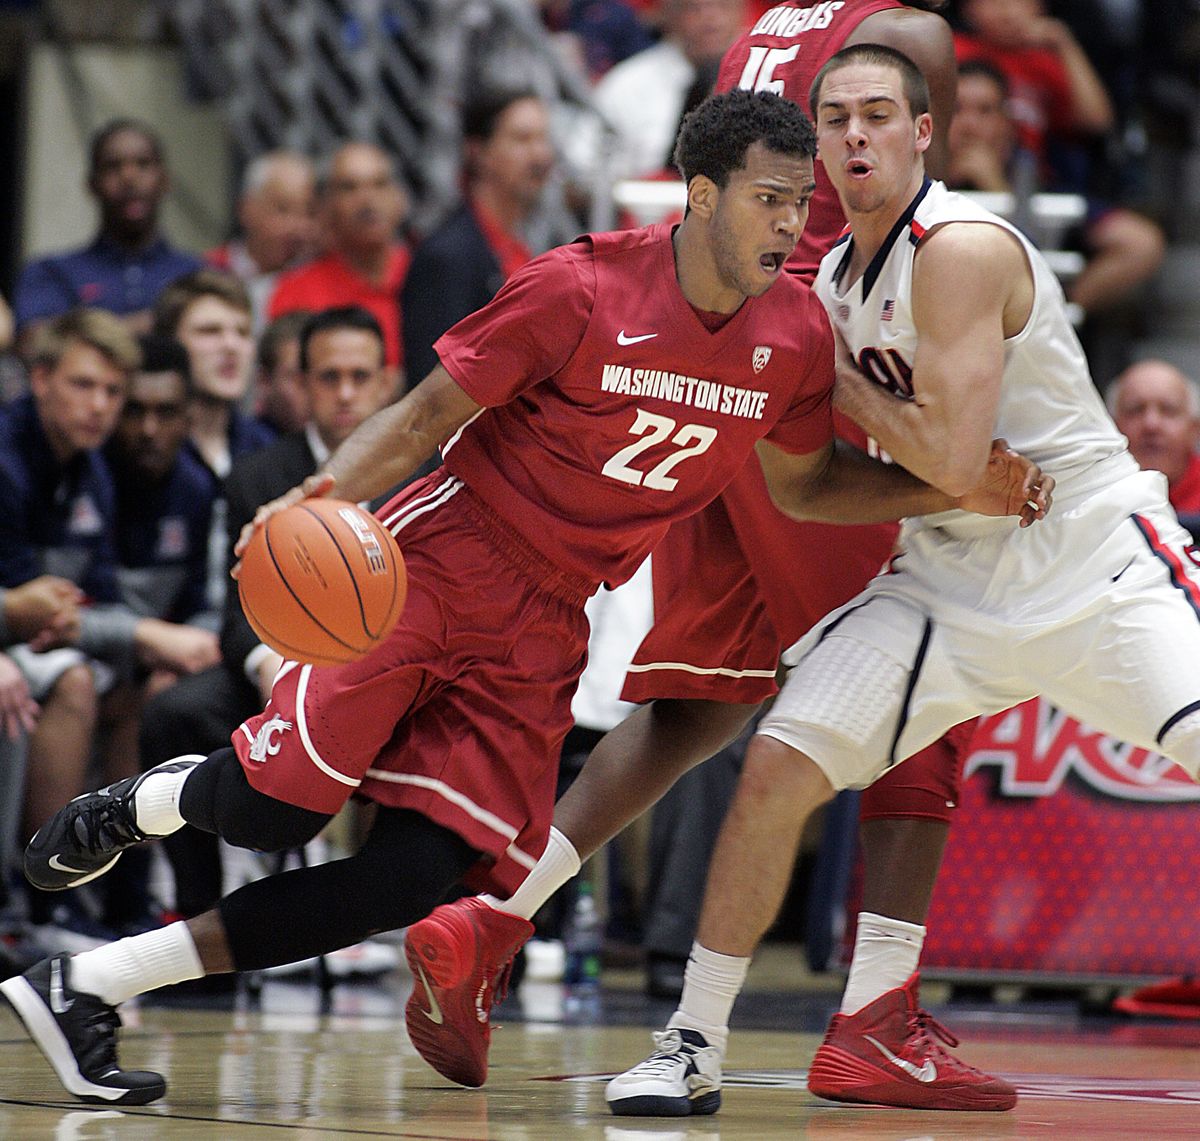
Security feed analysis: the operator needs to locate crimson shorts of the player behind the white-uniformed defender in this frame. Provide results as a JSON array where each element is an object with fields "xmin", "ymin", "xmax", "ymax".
[{"xmin": 622, "ymin": 463, "xmax": 973, "ymax": 821}]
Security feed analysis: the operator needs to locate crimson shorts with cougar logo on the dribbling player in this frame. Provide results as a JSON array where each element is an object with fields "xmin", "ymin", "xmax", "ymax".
[{"xmin": 233, "ymin": 472, "xmax": 593, "ymax": 895}]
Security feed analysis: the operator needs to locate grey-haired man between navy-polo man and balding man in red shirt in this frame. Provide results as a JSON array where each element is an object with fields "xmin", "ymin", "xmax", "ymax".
[{"xmin": 204, "ymin": 150, "xmax": 317, "ymax": 336}]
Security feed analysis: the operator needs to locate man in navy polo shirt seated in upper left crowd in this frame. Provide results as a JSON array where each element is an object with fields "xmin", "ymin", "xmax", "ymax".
[{"xmin": 13, "ymin": 119, "xmax": 200, "ymax": 355}]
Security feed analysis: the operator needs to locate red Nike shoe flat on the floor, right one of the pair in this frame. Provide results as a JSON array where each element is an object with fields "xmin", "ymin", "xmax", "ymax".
[{"xmin": 809, "ymin": 974, "xmax": 1016, "ymax": 1110}]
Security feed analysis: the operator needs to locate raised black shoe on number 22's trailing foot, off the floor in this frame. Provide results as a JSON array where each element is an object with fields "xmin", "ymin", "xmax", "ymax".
[{"xmin": 25, "ymin": 757, "xmax": 203, "ymax": 891}]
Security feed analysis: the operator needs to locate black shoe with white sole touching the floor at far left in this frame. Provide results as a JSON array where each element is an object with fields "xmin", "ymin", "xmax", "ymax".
[{"xmin": 0, "ymin": 955, "xmax": 167, "ymax": 1105}]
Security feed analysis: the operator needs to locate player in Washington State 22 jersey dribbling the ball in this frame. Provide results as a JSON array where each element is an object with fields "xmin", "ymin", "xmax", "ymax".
[{"xmin": 0, "ymin": 91, "xmax": 1049, "ymax": 1104}]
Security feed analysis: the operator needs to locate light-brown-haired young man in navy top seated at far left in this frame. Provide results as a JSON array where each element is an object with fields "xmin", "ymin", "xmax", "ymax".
[{"xmin": 0, "ymin": 310, "xmax": 215, "ymax": 939}]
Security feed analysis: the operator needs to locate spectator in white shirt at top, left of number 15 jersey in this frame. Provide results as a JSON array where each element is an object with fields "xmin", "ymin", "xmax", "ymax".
[{"xmin": 571, "ymin": 0, "xmax": 746, "ymax": 179}]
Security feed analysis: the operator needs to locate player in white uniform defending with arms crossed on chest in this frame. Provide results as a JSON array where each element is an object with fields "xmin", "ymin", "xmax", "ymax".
[{"xmin": 607, "ymin": 44, "xmax": 1200, "ymax": 1116}]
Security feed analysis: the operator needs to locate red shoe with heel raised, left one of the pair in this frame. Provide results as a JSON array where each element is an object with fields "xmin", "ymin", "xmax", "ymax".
[{"xmin": 404, "ymin": 896, "xmax": 533, "ymax": 1086}]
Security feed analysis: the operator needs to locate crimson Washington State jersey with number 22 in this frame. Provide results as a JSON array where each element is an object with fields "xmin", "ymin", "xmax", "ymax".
[{"xmin": 434, "ymin": 226, "xmax": 833, "ymax": 584}]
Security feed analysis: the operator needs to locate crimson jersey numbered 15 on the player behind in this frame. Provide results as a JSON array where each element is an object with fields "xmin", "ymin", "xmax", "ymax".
[{"xmin": 716, "ymin": 0, "xmax": 905, "ymax": 281}]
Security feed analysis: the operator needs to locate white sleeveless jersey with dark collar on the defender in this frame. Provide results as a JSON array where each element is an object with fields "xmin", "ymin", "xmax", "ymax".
[{"xmin": 815, "ymin": 180, "xmax": 1136, "ymax": 544}]
